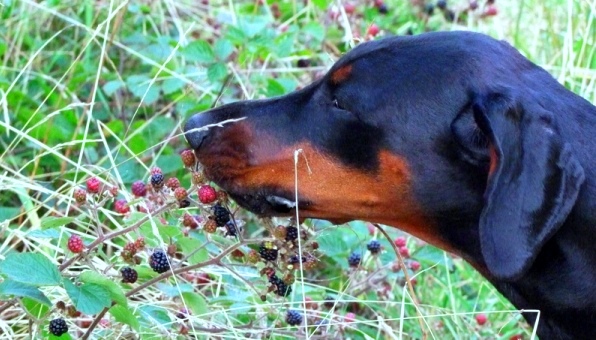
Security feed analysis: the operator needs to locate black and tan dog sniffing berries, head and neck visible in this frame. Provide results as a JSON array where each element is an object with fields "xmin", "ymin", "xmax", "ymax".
[{"xmin": 184, "ymin": 32, "xmax": 596, "ymax": 339}]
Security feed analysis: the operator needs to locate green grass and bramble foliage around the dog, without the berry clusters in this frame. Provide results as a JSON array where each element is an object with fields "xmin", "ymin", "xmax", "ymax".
[{"xmin": 0, "ymin": 0, "xmax": 596, "ymax": 339}]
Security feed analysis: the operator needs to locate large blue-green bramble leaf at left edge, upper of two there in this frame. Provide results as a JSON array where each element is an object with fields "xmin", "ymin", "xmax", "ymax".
[{"xmin": 0, "ymin": 253, "xmax": 62, "ymax": 286}]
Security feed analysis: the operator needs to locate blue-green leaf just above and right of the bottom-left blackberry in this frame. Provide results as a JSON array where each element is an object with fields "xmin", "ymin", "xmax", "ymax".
[{"xmin": 64, "ymin": 280, "xmax": 112, "ymax": 314}]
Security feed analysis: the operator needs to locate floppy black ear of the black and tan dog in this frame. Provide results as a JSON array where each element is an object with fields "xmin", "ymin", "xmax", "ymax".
[{"xmin": 472, "ymin": 94, "xmax": 584, "ymax": 280}]
